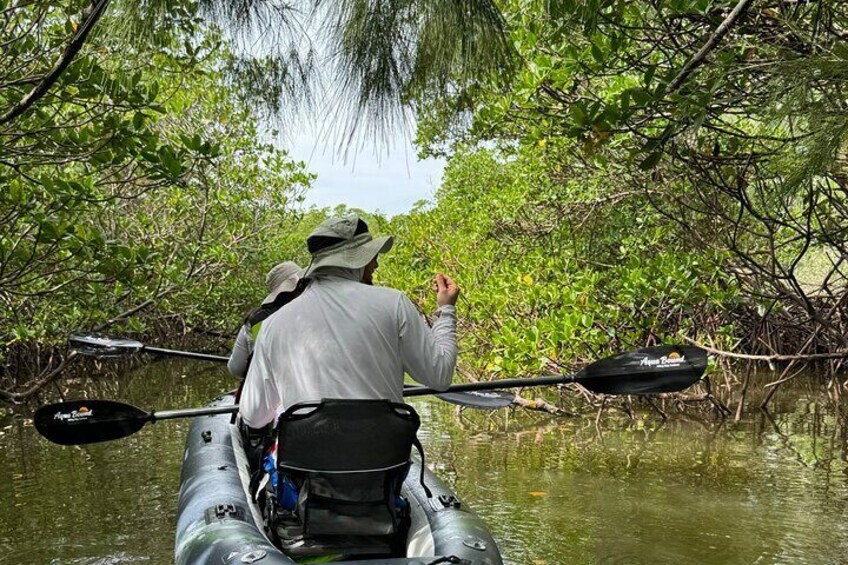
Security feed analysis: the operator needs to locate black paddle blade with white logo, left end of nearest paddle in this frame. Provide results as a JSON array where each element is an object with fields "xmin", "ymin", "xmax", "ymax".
[{"xmin": 33, "ymin": 400, "xmax": 149, "ymax": 445}]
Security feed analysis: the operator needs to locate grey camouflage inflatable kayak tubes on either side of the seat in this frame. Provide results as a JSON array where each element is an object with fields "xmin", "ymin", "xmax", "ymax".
[{"xmin": 175, "ymin": 395, "xmax": 502, "ymax": 565}]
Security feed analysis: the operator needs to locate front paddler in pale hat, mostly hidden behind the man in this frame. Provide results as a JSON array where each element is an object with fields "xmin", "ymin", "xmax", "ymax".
[{"xmin": 227, "ymin": 261, "xmax": 303, "ymax": 379}]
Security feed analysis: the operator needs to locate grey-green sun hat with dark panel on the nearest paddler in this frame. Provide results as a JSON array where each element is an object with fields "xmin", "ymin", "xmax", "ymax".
[{"xmin": 303, "ymin": 214, "xmax": 394, "ymax": 277}]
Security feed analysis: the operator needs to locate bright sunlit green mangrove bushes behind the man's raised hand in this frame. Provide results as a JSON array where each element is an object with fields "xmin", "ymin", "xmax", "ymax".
[{"xmin": 379, "ymin": 143, "xmax": 737, "ymax": 378}]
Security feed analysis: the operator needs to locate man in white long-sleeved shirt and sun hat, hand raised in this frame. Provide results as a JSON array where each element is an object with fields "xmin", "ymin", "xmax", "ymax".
[{"xmin": 239, "ymin": 214, "xmax": 459, "ymax": 428}]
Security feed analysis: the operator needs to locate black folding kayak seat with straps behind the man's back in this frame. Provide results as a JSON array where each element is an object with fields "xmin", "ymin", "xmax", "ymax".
[{"xmin": 277, "ymin": 399, "xmax": 420, "ymax": 554}]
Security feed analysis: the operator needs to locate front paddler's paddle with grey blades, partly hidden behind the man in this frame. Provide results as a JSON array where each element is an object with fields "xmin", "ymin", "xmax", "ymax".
[{"xmin": 68, "ymin": 334, "xmax": 514, "ymax": 409}]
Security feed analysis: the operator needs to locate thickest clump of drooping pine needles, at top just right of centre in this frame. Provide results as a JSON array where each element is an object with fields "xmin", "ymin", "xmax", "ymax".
[{"xmin": 319, "ymin": 0, "xmax": 513, "ymax": 142}]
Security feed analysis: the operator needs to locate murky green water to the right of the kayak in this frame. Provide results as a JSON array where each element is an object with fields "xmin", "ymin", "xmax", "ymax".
[{"xmin": 414, "ymin": 394, "xmax": 848, "ymax": 564}]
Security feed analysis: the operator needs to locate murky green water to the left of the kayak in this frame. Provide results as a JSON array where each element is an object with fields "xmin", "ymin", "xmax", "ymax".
[{"xmin": 0, "ymin": 362, "xmax": 233, "ymax": 565}]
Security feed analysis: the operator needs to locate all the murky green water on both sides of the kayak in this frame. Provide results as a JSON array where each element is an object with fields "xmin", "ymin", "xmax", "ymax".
[{"xmin": 0, "ymin": 362, "xmax": 848, "ymax": 565}]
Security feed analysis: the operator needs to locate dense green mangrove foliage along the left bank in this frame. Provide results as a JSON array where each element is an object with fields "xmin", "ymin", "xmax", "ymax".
[{"xmin": 0, "ymin": 3, "xmax": 310, "ymax": 396}]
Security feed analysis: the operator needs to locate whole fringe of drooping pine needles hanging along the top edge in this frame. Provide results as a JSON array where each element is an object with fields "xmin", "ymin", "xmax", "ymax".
[{"xmin": 100, "ymin": 0, "xmax": 515, "ymax": 143}]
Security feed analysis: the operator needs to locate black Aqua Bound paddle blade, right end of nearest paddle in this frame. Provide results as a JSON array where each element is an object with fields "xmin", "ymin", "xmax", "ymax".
[{"xmin": 574, "ymin": 345, "xmax": 707, "ymax": 394}]
